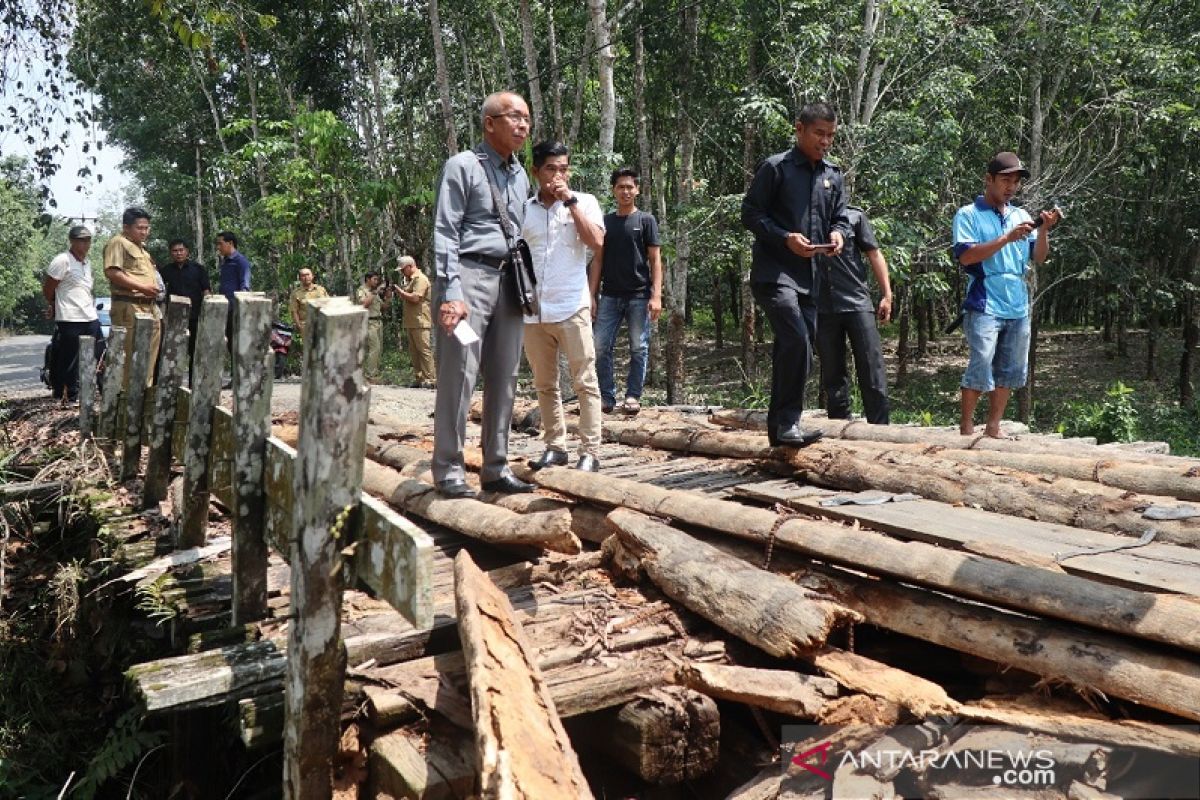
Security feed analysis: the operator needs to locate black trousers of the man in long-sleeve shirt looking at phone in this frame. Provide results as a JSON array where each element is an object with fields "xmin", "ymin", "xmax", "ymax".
[{"xmin": 751, "ymin": 283, "xmax": 817, "ymax": 437}]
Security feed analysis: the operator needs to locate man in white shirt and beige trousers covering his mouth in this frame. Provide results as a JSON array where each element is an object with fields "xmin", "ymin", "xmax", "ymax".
[{"xmin": 521, "ymin": 142, "xmax": 604, "ymax": 473}]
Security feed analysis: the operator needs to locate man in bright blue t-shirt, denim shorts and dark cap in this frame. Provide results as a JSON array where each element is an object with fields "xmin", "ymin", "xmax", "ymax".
[{"xmin": 954, "ymin": 152, "xmax": 1061, "ymax": 438}]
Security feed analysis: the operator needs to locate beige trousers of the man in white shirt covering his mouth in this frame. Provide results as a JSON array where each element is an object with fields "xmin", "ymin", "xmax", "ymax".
[{"xmin": 524, "ymin": 308, "xmax": 600, "ymax": 456}]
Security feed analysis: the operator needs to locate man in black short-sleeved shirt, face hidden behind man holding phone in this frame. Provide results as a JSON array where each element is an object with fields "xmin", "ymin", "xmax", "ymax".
[{"xmin": 817, "ymin": 206, "xmax": 892, "ymax": 425}]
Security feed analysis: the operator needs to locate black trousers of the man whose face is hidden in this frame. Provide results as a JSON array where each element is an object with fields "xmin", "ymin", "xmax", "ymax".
[{"xmin": 817, "ymin": 311, "xmax": 889, "ymax": 425}]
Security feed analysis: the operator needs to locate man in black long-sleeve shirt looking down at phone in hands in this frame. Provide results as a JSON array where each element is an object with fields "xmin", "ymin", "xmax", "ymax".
[{"xmin": 742, "ymin": 103, "xmax": 851, "ymax": 447}]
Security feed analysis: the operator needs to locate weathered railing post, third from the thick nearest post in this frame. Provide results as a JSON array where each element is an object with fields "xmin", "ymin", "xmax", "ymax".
[{"xmin": 176, "ymin": 295, "xmax": 229, "ymax": 547}]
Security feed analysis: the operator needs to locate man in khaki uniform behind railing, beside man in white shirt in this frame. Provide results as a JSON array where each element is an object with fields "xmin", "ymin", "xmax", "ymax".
[{"xmin": 104, "ymin": 207, "xmax": 162, "ymax": 387}]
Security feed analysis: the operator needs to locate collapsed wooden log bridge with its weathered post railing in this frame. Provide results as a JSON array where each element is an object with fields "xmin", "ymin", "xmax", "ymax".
[{"xmin": 87, "ymin": 296, "xmax": 1200, "ymax": 799}]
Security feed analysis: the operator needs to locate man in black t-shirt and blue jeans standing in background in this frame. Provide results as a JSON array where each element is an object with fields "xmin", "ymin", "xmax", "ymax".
[{"xmin": 588, "ymin": 167, "xmax": 662, "ymax": 414}]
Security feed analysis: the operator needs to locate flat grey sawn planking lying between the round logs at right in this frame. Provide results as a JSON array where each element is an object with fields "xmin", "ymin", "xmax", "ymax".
[{"xmin": 734, "ymin": 481, "xmax": 1200, "ymax": 595}]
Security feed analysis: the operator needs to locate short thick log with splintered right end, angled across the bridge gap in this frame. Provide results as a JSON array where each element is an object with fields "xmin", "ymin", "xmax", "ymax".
[{"xmin": 608, "ymin": 509, "xmax": 862, "ymax": 658}]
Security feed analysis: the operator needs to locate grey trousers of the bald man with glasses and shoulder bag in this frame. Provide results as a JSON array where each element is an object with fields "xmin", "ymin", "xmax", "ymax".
[{"xmin": 433, "ymin": 260, "xmax": 524, "ymax": 481}]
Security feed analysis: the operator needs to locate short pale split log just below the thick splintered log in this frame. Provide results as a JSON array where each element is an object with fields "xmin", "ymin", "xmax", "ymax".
[{"xmin": 679, "ymin": 662, "xmax": 838, "ymax": 720}]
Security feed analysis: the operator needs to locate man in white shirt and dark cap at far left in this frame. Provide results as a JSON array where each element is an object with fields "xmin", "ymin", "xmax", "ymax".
[{"xmin": 42, "ymin": 225, "xmax": 101, "ymax": 401}]
